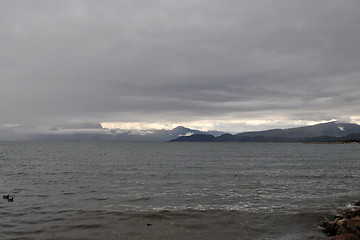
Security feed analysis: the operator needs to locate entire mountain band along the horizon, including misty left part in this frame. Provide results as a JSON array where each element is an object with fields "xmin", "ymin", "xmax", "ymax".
[{"xmin": 0, "ymin": 122, "xmax": 360, "ymax": 142}]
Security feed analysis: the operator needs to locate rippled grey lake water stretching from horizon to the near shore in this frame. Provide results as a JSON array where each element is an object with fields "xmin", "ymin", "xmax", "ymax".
[{"xmin": 0, "ymin": 142, "xmax": 360, "ymax": 240}]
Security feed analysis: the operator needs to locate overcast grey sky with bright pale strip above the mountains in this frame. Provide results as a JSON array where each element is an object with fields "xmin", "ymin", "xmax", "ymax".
[{"xmin": 0, "ymin": 0, "xmax": 360, "ymax": 131}]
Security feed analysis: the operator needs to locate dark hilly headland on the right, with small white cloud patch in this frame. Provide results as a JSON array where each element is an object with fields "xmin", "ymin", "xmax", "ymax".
[{"xmin": 171, "ymin": 122, "xmax": 360, "ymax": 142}]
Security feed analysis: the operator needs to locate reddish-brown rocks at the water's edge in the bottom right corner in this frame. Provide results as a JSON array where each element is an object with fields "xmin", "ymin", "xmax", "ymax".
[{"xmin": 322, "ymin": 202, "xmax": 360, "ymax": 240}]
